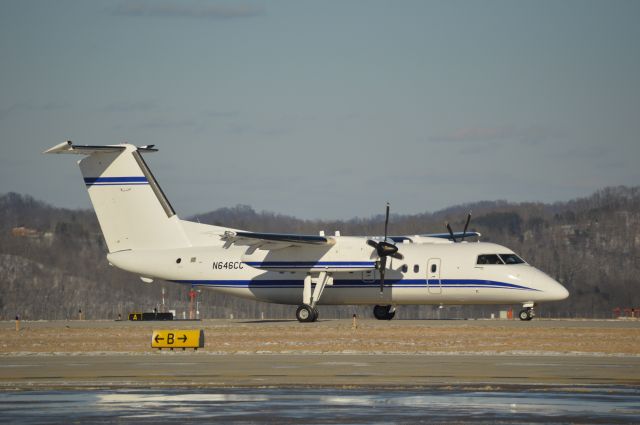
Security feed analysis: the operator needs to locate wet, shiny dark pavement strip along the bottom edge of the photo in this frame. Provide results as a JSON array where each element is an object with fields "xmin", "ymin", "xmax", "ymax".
[{"xmin": 0, "ymin": 386, "xmax": 640, "ymax": 424}]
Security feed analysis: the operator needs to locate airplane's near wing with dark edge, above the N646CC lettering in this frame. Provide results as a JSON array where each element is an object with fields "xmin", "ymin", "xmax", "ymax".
[{"xmin": 222, "ymin": 231, "xmax": 335, "ymax": 249}]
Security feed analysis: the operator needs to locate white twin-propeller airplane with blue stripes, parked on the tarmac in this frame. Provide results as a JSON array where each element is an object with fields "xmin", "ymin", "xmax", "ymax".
[{"xmin": 45, "ymin": 141, "xmax": 569, "ymax": 322}]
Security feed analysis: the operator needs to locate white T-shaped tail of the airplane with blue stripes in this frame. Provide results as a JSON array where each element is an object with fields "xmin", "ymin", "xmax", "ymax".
[{"xmin": 44, "ymin": 141, "xmax": 190, "ymax": 252}]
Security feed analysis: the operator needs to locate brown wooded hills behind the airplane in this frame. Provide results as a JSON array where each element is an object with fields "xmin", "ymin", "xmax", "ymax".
[{"xmin": 0, "ymin": 187, "xmax": 640, "ymax": 319}]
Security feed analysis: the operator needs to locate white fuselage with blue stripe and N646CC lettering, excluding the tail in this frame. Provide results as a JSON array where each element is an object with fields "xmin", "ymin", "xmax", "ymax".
[{"xmin": 108, "ymin": 235, "xmax": 568, "ymax": 305}]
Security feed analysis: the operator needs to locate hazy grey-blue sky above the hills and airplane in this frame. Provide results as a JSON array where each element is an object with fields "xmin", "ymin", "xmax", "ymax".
[{"xmin": 0, "ymin": 0, "xmax": 640, "ymax": 218}]
